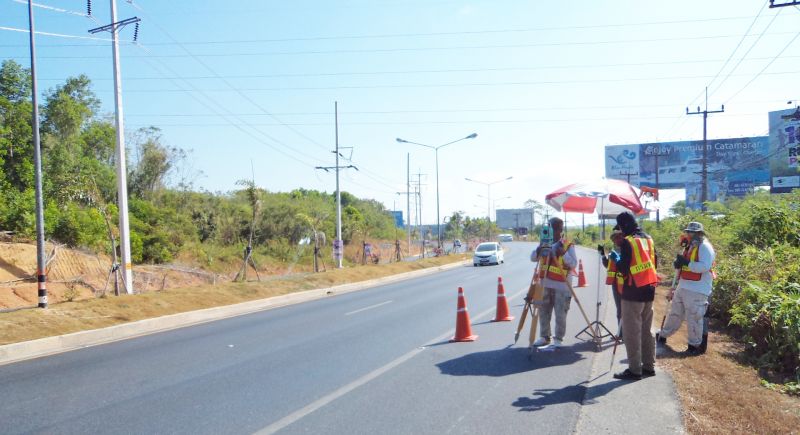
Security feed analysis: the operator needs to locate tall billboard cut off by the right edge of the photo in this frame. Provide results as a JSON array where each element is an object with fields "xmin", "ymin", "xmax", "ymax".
[{"xmin": 769, "ymin": 108, "xmax": 800, "ymax": 193}]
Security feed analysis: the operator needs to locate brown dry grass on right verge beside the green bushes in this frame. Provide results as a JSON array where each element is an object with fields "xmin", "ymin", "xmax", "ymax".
[{"xmin": 654, "ymin": 287, "xmax": 800, "ymax": 434}]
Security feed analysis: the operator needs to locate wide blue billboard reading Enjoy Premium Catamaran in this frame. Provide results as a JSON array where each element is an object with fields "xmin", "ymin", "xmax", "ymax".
[{"xmin": 605, "ymin": 136, "xmax": 770, "ymax": 191}]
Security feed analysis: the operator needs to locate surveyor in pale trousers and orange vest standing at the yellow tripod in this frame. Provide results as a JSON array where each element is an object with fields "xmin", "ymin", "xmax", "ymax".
[{"xmin": 531, "ymin": 217, "xmax": 578, "ymax": 347}]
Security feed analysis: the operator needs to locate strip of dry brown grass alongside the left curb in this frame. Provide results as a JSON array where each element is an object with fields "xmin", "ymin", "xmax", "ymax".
[{"xmin": 0, "ymin": 254, "xmax": 467, "ymax": 345}]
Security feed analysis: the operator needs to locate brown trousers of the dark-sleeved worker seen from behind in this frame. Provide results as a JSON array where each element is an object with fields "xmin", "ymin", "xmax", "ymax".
[{"xmin": 622, "ymin": 299, "xmax": 656, "ymax": 375}]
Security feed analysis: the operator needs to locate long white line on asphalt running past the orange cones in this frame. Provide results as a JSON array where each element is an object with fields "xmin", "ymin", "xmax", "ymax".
[{"xmin": 255, "ymin": 287, "xmax": 528, "ymax": 435}]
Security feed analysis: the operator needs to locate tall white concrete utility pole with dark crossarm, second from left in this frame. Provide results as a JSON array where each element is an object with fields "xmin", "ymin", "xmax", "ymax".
[{"xmin": 89, "ymin": 0, "xmax": 141, "ymax": 294}]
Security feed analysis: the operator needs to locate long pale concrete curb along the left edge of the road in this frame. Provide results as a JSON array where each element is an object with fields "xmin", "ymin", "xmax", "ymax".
[{"xmin": 0, "ymin": 261, "xmax": 468, "ymax": 366}]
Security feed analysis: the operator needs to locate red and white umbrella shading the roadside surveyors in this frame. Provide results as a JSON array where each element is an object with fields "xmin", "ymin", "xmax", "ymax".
[{"xmin": 545, "ymin": 178, "xmax": 648, "ymax": 216}]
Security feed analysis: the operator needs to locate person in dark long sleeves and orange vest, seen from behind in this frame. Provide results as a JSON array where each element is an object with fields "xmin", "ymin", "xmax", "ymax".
[{"xmin": 614, "ymin": 212, "xmax": 658, "ymax": 380}]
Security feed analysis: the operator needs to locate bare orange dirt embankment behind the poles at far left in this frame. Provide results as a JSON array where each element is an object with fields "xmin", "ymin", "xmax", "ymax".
[{"xmin": 0, "ymin": 243, "xmax": 217, "ymax": 309}]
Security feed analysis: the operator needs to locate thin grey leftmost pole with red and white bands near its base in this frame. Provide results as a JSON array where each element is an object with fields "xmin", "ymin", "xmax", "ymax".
[{"xmin": 28, "ymin": 0, "xmax": 47, "ymax": 308}]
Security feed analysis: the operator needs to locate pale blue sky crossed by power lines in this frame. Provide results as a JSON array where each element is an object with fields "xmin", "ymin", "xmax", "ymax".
[{"xmin": 0, "ymin": 0, "xmax": 800, "ymax": 230}]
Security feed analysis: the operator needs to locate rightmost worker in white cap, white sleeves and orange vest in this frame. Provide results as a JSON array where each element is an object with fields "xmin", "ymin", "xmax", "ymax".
[{"xmin": 656, "ymin": 222, "xmax": 716, "ymax": 355}]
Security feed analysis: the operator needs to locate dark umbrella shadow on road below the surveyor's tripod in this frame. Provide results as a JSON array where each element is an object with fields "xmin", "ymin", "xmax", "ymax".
[{"xmin": 436, "ymin": 343, "xmax": 592, "ymax": 377}]
